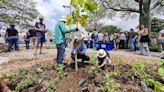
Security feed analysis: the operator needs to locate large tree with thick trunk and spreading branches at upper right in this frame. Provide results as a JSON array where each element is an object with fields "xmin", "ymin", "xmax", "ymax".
[{"xmin": 98, "ymin": 0, "xmax": 164, "ymax": 31}]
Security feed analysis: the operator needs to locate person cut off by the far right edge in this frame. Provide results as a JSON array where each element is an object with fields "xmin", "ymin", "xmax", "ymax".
[{"xmin": 158, "ymin": 30, "xmax": 164, "ymax": 51}]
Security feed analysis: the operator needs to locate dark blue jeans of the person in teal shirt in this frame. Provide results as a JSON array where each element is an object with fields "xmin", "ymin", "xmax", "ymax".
[{"xmin": 56, "ymin": 43, "xmax": 66, "ymax": 64}]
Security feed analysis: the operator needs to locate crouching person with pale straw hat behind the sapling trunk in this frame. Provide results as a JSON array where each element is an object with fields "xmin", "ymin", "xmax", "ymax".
[{"xmin": 71, "ymin": 31, "xmax": 90, "ymax": 63}]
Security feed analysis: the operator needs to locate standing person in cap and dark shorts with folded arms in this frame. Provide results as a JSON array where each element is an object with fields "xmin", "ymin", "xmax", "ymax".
[{"xmin": 34, "ymin": 16, "xmax": 47, "ymax": 56}]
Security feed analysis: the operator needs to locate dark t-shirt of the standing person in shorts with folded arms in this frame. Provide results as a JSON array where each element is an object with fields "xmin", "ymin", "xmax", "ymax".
[{"xmin": 35, "ymin": 22, "xmax": 46, "ymax": 37}]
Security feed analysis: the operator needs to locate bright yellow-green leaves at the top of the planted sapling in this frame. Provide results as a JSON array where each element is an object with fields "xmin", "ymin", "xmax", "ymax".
[{"xmin": 66, "ymin": 0, "xmax": 97, "ymax": 26}]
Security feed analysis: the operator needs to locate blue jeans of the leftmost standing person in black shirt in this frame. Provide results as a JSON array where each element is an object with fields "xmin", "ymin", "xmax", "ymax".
[{"xmin": 8, "ymin": 36, "xmax": 19, "ymax": 51}]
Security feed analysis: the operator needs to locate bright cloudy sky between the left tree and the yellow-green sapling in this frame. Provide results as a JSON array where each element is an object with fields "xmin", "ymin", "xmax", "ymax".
[{"xmin": 35, "ymin": 0, "xmax": 69, "ymax": 30}]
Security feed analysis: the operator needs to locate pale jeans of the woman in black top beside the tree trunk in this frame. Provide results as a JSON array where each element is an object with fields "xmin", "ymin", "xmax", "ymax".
[{"xmin": 140, "ymin": 42, "xmax": 150, "ymax": 56}]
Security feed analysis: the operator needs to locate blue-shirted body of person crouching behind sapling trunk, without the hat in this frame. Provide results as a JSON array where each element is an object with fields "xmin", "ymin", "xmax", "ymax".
[{"xmin": 71, "ymin": 32, "xmax": 90, "ymax": 63}]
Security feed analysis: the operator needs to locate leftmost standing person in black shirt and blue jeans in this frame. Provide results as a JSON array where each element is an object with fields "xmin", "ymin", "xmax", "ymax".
[{"xmin": 5, "ymin": 24, "xmax": 19, "ymax": 51}]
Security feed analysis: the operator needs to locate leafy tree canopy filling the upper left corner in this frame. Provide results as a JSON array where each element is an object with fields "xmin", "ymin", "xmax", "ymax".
[{"xmin": 0, "ymin": 0, "xmax": 39, "ymax": 28}]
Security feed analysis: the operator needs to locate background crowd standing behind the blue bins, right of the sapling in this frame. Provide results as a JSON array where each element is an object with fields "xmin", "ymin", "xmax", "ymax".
[{"xmin": 81, "ymin": 24, "xmax": 150, "ymax": 56}]
